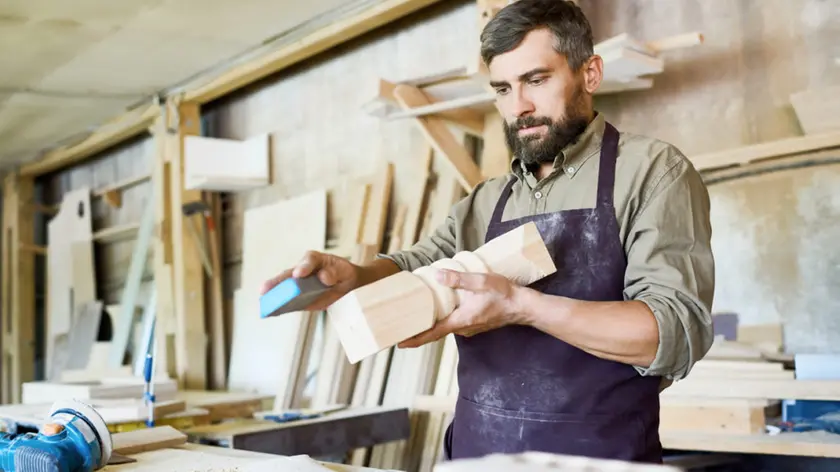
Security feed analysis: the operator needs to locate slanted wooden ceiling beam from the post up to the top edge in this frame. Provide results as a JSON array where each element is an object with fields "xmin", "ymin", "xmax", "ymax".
[{"xmin": 184, "ymin": 0, "xmax": 440, "ymax": 104}]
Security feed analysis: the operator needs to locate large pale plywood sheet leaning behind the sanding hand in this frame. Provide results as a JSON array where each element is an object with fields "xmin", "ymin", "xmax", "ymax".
[{"xmin": 228, "ymin": 189, "xmax": 327, "ymax": 397}]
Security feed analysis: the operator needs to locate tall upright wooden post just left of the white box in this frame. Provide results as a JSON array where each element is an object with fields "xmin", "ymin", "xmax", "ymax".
[{"xmin": 166, "ymin": 98, "xmax": 207, "ymax": 389}]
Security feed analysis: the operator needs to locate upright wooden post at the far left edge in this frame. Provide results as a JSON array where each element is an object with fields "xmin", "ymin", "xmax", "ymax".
[{"xmin": 0, "ymin": 173, "xmax": 35, "ymax": 403}]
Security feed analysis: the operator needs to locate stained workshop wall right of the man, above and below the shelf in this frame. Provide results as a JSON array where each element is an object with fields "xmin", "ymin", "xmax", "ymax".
[{"xmin": 581, "ymin": 0, "xmax": 840, "ymax": 352}]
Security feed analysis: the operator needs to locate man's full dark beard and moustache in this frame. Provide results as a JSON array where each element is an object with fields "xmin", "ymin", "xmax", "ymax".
[{"xmin": 504, "ymin": 95, "xmax": 589, "ymax": 166}]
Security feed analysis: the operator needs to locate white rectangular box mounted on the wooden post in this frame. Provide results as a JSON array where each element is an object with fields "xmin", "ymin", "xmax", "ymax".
[{"xmin": 184, "ymin": 134, "xmax": 270, "ymax": 192}]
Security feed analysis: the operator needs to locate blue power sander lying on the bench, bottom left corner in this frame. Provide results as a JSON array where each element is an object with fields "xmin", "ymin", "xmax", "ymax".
[{"xmin": 0, "ymin": 400, "xmax": 113, "ymax": 472}]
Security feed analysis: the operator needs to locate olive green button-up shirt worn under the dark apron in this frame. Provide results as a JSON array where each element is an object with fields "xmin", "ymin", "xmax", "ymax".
[{"xmin": 382, "ymin": 113, "xmax": 714, "ymax": 385}]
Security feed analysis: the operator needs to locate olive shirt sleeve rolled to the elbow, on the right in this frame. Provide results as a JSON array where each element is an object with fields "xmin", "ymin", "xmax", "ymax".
[{"xmin": 624, "ymin": 148, "xmax": 714, "ymax": 380}]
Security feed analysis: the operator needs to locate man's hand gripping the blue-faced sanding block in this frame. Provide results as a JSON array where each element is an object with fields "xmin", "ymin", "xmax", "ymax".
[{"xmin": 260, "ymin": 251, "xmax": 361, "ymax": 311}]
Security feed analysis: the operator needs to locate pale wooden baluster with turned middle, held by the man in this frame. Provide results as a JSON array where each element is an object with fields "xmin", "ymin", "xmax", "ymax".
[{"xmin": 328, "ymin": 223, "xmax": 556, "ymax": 364}]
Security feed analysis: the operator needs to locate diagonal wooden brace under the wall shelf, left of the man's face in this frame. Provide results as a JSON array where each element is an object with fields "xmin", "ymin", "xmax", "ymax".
[{"xmin": 394, "ymin": 85, "xmax": 483, "ymax": 193}]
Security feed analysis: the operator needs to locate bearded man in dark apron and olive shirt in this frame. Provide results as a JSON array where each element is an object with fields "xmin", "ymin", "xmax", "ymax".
[{"xmin": 263, "ymin": 0, "xmax": 714, "ymax": 462}]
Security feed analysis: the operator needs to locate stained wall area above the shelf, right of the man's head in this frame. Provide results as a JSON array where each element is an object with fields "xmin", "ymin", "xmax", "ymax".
[{"xmin": 580, "ymin": 0, "xmax": 840, "ymax": 155}]
